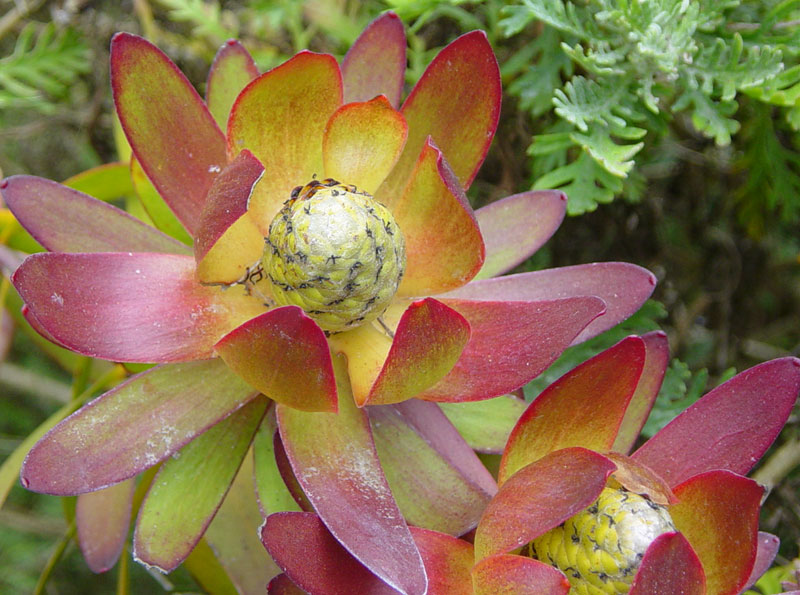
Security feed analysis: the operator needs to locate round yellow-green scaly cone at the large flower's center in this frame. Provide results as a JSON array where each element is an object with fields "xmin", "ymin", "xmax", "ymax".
[{"xmin": 261, "ymin": 179, "xmax": 406, "ymax": 333}]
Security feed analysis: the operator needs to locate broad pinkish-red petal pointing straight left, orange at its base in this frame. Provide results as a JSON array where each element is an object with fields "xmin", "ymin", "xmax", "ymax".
[{"xmin": 12, "ymin": 252, "xmax": 264, "ymax": 362}]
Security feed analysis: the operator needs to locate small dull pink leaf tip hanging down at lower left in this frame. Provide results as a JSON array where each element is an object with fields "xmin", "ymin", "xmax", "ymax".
[{"xmin": 75, "ymin": 479, "xmax": 136, "ymax": 572}]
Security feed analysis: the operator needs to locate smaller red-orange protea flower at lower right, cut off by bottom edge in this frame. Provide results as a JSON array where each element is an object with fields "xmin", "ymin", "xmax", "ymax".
[{"xmin": 262, "ymin": 333, "xmax": 800, "ymax": 595}]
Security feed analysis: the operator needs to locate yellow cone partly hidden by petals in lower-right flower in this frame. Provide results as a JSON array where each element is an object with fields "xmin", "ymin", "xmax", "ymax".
[{"xmin": 530, "ymin": 488, "xmax": 676, "ymax": 595}]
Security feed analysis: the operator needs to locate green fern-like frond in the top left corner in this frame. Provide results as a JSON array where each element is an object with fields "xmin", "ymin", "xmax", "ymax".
[{"xmin": 0, "ymin": 24, "xmax": 89, "ymax": 113}]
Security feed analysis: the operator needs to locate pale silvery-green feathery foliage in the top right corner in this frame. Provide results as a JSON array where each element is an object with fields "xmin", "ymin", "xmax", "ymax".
[{"xmin": 500, "ymin": 0, "xmax": 800, "ymax": 214}]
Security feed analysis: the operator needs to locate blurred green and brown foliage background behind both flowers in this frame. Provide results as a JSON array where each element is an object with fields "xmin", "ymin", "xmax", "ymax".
[{"xmin": 0, "ymin": 0, "xmax": 800, "ymax": 593}]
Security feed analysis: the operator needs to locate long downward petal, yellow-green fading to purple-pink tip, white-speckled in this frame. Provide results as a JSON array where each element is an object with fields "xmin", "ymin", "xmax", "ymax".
[{"xmin": 277, "ymin": 356, "xmax": 427, "ymax": 594}]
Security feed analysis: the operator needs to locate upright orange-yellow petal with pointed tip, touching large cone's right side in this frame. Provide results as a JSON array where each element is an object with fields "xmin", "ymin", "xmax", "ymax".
[{"xmin": 386, "ymin": 139, "xmax": 484, "ymax": 296}]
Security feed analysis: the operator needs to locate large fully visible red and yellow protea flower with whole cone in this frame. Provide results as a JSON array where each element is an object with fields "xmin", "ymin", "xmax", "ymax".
[{"xmin": 1, "ymin": 14, "xmax": 655, "ymax": 592}]
